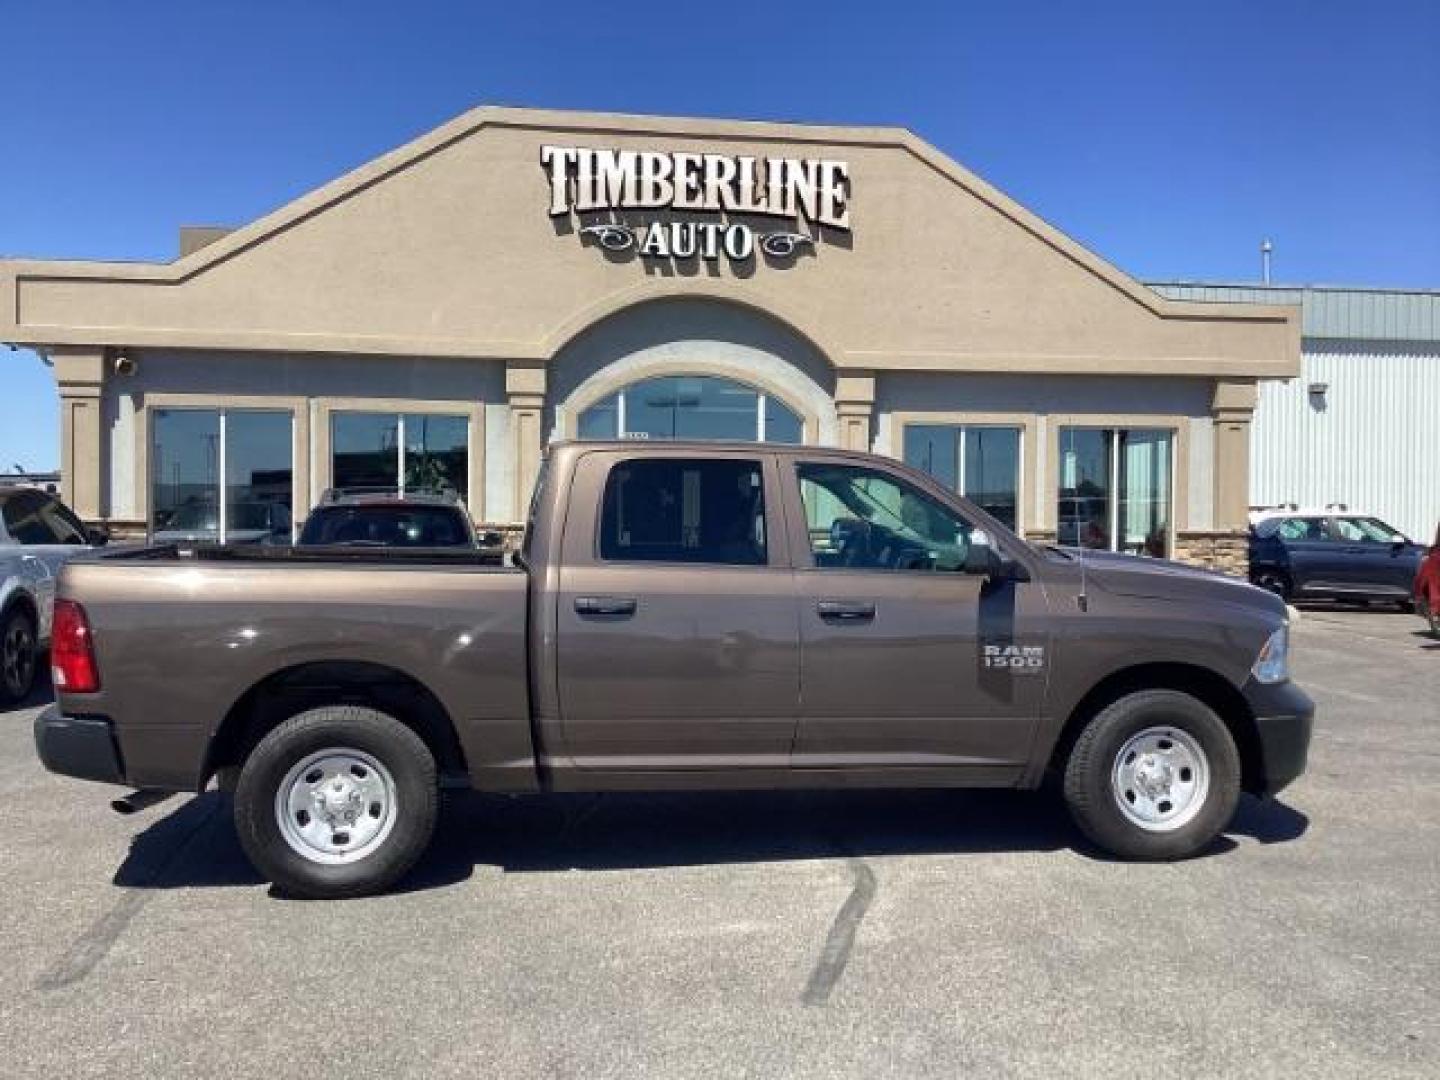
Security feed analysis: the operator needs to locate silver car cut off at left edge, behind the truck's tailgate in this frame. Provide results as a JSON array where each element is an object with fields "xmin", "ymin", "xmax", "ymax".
[{"xmin": 0, "ymin": 487, "xmax": 107, "ymax": 706}]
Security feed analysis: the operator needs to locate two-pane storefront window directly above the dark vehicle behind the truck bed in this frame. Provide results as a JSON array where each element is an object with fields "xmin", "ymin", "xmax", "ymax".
[{"xmin": 330, "ymin": 412, "xmax": 469, "ymax": 495}]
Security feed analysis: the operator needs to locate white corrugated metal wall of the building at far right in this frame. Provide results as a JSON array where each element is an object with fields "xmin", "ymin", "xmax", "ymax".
[{"xmin": 1250, "ymin": 342, "xmax": 1440, "ymax": 541}]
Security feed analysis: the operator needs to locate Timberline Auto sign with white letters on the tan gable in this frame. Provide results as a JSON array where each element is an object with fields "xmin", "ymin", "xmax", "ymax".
[{"xmin": 540, "ymin": 145, "xmax": 850, "ymax": 262}]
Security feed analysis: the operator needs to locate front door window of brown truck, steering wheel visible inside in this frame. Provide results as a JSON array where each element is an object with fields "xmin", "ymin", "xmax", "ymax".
[{"xmin": 796, "ymin": 464, "xmax": 973, "ymax": 572}]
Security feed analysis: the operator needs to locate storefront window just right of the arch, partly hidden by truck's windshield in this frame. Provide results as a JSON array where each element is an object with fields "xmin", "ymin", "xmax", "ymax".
[{"xmin": 904, "ymin": 423, "xmax": 1021, "ymax": 528}]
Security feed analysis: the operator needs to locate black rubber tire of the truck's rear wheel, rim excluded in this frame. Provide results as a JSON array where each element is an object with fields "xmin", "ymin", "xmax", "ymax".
[{"xmin": 235, "ymin": 706, "xmax": 439, "ymax": 900}]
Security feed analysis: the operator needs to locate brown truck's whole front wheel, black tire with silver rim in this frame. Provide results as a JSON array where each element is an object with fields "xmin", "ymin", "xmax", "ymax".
[{"xmin": 1064, "ymin": 690, "xmax": 1240, "ymax": 860}]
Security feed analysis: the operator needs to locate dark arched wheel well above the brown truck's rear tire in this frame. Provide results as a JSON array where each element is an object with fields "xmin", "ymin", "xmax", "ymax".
[{"xmin": 200, "ymin": 661, "xmax": 467, "ymax": 788}]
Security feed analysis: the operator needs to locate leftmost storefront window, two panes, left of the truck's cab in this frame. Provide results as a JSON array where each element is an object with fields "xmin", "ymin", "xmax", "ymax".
[{"xmin": 150, "ymin": 409, "xmax": 294, "ymax": 544}]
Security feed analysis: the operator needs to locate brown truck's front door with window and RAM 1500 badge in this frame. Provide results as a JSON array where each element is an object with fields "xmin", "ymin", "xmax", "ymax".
[{"xmin": 788, "ymin": 459, "xmax": 1050, "ymax": 768}]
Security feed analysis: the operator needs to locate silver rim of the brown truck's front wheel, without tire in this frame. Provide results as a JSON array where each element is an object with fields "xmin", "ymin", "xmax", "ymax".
[{"xmin": 1110, "ymin": 727, "xmax": 1210, "ymax": 832}]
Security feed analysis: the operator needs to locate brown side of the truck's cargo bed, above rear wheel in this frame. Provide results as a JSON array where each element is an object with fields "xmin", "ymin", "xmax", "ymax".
[{"xmin": 59, "ymin": 546, "xmax": 536, "ymax": 791}]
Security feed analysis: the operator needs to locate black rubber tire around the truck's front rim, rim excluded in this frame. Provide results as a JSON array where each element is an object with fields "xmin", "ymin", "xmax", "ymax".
[{"xmin": 1064, "ymin": 690, "xmax": 1240, "ymax": 861}]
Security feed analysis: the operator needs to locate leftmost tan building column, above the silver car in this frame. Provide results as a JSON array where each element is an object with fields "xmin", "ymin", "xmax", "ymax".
[{"xmin": 45, "ymin": 346, "xmax": 109, "ymax": 521}]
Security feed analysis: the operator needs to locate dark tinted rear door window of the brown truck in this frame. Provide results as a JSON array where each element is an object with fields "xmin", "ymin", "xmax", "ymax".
[{"xmin": 600, "ymin": 458, "xmax": 766, "ymax": 566}]
